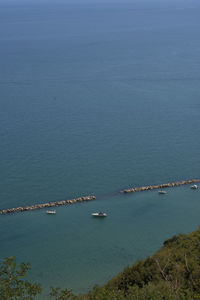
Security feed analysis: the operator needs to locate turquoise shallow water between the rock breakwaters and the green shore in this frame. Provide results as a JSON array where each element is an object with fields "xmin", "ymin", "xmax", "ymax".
[{"xmin": 0, "ymin": 187, "xmax": 200, "ymax": 292}]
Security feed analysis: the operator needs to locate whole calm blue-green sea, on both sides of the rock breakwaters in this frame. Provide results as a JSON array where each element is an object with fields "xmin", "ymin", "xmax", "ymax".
[{"xmin": 0, "ymin": 0, "xmax": 200, "ymax": 299}]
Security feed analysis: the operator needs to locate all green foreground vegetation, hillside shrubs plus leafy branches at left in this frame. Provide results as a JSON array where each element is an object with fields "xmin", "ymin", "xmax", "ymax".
[{"xmin": 0, "ymin": 230, "xmax": 200, "ymax": 300}]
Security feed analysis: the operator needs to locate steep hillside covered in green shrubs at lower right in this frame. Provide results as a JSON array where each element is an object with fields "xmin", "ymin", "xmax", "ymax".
[{"xmin": 80, "ymin": 230, "xmax": 200, "ymax": 300}]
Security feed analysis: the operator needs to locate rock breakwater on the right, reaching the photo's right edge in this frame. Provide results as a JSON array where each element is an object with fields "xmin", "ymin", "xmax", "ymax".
[{"xmin": 123, "ymin": 179, "xmax": 200, "ymax": 193}]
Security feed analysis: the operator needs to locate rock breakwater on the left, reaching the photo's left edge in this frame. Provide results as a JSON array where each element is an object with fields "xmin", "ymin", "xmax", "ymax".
[{"xmin": 0, "ymin": 196, "xmax": 96, "ymax": 215}]
